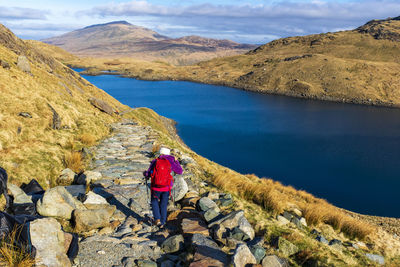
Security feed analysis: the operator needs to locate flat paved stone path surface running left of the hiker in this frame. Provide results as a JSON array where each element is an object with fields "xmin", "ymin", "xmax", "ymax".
[{"xmin": 76, "ymin": 121, "xmax": 168, "ymax": 267}]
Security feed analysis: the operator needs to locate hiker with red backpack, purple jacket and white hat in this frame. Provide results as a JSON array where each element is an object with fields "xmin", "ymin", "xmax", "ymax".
[{"xmin": 143, "ymin": 147, "xmax": 183, "ymax": 228}]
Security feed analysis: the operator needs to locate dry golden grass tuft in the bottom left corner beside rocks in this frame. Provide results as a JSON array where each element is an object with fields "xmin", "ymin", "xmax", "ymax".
[{"xmin": 0, "ymin": 229, "xmax": 35, "ymax": 267}]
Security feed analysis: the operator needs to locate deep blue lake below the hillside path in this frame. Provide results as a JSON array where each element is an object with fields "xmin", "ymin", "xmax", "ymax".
[{"xmin": 79, "ymin": 72, "xmax": 400, "ymax": 217}]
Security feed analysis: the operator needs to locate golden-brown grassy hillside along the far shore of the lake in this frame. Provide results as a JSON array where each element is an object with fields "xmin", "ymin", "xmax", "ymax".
[{"xmin": 57, "ymin": 18, "xmax": 400, "ymax": 107}]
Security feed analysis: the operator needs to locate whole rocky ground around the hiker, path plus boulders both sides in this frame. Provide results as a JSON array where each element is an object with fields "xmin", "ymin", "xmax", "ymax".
[{"xmin": 5, "ymin": 119, "xmax": 398, "ymax": 267}]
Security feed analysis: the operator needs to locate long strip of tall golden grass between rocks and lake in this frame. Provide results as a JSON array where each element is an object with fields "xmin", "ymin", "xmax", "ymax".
[{"xmin": 192, "ymin": 154, "xmax": 374, "ymax": 239}]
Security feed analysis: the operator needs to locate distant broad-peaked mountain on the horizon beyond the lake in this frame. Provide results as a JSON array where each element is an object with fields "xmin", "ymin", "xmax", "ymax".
[{"xmin": 43, "ymin": 21, "xmax": 255, "ymax": 65}]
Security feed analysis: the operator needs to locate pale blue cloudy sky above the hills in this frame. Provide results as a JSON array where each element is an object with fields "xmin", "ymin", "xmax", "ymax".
[{"xmin": 0, "ymin": 0, "xmax": 400, "ymax": 44}]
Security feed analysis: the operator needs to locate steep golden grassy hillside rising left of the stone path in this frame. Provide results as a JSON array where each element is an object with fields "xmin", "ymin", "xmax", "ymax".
[{"xmin": 0, "ymin": 25, "xmax": 127, "ymax": 186}]
